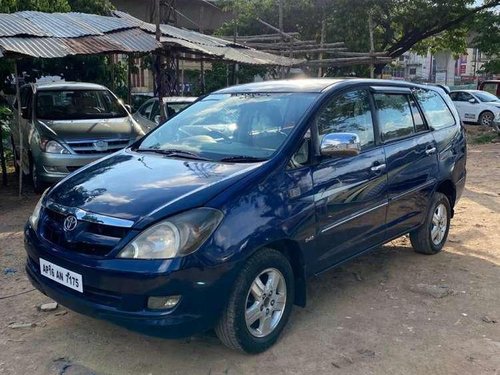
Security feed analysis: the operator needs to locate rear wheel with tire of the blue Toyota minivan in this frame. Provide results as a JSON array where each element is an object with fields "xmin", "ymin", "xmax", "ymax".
[{"xmin": 410, "ymin": 193, "xmax": 451, "ymax": 255}]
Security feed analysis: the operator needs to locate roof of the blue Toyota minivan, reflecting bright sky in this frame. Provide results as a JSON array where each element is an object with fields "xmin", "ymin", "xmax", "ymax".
[{"xmin": 214, "ymin": 78, "xmax": 430, "ymax": 94}]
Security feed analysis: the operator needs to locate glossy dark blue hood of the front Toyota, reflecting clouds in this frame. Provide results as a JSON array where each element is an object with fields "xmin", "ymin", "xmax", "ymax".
[{"xmin": 47, "ymin": 150, "xmax": 262, "ymax": 223}]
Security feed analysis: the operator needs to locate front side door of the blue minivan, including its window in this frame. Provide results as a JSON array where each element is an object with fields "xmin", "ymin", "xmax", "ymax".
[{"xmin": 311, "ymin": 88, "xmax": 387, "ymax": 272}]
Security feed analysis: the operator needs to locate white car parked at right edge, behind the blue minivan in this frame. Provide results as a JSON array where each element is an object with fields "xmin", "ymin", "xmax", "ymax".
[{"xmin": 450, "ymin": 90, "xmax": 500, "ymax": 126}]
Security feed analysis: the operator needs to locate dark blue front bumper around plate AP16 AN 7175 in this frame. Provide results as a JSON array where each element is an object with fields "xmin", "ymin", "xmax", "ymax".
[{"xmin": 25, "ymin": 224, "xmax": 235, "ymax": 338}]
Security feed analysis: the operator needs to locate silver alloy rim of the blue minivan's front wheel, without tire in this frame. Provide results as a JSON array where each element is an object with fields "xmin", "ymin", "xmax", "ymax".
[{"xmin": 245, "ymin": 268, "xmax": 286, "ymax": 337}]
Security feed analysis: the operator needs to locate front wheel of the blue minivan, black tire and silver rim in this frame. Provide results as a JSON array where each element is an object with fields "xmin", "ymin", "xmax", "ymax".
[{"xmin": 215, "ymin": 248, "xmax": 295, "ymax": 353}]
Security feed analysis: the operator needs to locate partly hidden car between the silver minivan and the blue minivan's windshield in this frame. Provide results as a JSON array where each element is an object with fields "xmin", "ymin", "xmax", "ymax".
[{"xmin": 134, "ymin": 96, "xmax": 197, "ymax": 132}]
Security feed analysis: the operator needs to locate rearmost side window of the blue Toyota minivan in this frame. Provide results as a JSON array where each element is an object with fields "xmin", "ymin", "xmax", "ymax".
[{"xmin": 415, "ymin": 90, "xmax": 455, "ymax": 129}]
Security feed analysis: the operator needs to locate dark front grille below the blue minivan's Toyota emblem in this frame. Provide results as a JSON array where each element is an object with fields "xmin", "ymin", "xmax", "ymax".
[{"xmin": 40, "ymin": 208, "xmax": 128, "ymax": 257}]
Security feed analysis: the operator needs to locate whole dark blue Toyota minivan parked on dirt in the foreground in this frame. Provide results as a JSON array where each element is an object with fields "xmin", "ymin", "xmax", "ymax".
[{"xmin": 25, "ymin": 79, "xmax": 466, "ymax": 353}]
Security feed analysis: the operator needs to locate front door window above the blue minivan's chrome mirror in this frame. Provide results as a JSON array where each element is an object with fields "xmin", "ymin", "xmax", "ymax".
[{"xmin": 317, "ymin": 90, "xmax": 375, "ymax": 149}]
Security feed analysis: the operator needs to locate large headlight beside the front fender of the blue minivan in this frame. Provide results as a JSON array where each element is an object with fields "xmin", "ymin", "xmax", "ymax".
[{"xmin": 118, "ymin": 207, "xmax": 223, "ymax": 259}]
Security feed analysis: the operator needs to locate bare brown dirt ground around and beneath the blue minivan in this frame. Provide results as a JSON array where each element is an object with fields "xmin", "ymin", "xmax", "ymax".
[{"xmin": 0, "ymin": 144, "xmax": 500, "ymax": 375}]
